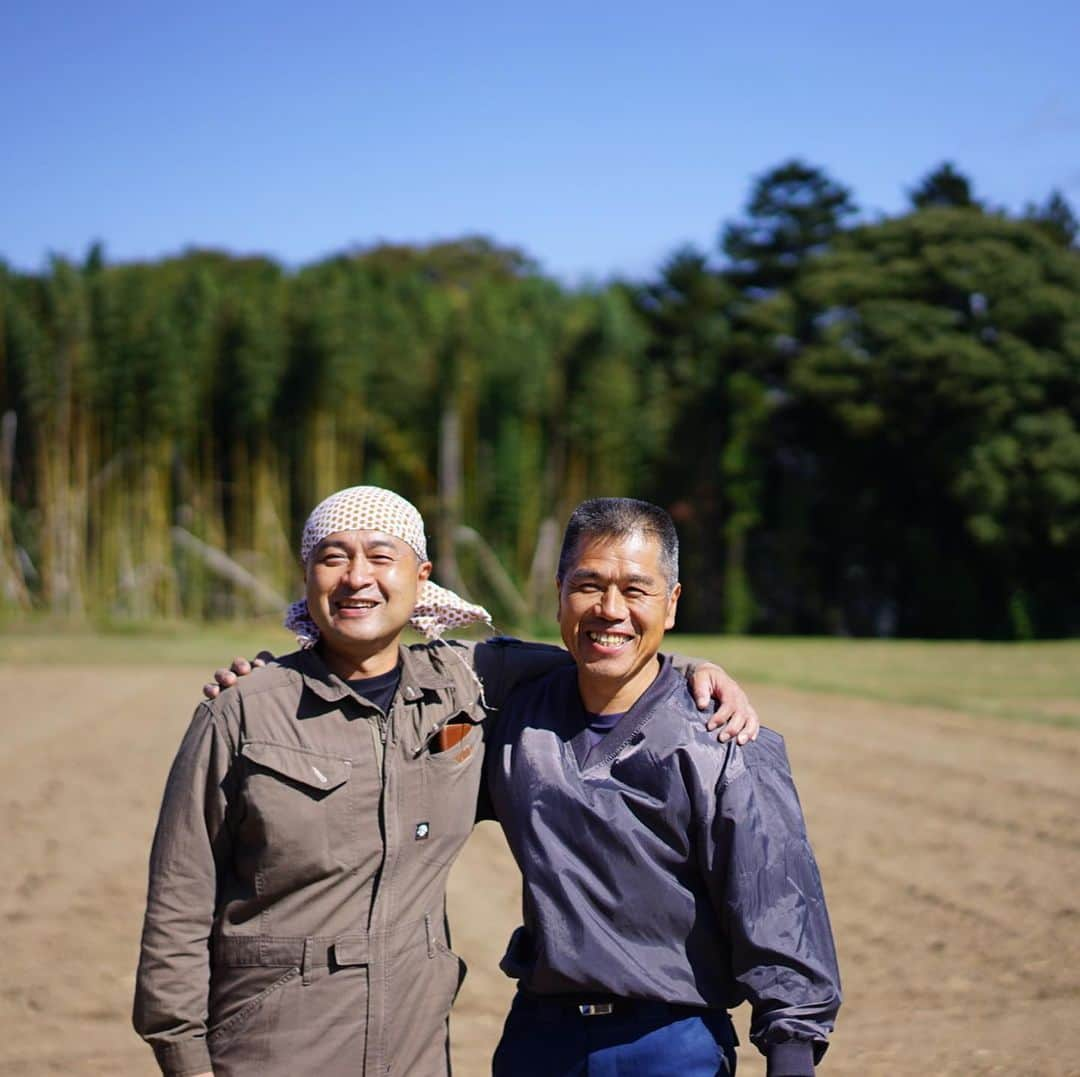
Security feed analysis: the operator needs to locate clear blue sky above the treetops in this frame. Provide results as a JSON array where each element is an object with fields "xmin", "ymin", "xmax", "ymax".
[{"xmin": 0, "ymin": 0, "xmax": 1080, "ymax": 281}]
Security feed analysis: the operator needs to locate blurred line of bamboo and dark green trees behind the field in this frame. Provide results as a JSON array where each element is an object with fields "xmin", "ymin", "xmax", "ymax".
[{"xmin": 0, "ymin": 161, "xmax": 1080, "ymax": 638}]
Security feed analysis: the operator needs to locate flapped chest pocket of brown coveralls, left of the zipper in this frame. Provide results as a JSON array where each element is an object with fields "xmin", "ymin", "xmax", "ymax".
[{"xmin": 241, "ymin": 741, "xmax": 354, "ymax": 885}]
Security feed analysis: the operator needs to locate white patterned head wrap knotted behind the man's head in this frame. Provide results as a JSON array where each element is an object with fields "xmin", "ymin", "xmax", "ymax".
[{"xmin": 285, "ymin": 486, "xmax": 491, "ymax": 647}]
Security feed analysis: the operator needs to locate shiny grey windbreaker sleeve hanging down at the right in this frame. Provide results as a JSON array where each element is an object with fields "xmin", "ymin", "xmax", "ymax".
[{"xmin": 710, "ymin": 729, "xmax": 840, "ymax": 1077}]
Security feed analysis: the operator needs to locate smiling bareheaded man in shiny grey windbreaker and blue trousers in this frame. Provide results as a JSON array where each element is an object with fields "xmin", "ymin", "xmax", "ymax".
[{"xmin": 488, "ymin": 498, "xmax": 840, "ymax": 1077}]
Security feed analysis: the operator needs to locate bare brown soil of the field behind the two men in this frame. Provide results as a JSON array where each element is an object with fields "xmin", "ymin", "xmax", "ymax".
[{"xmin": 0, "ymin": 667, "xmax": 1080, "ymax": 1077}]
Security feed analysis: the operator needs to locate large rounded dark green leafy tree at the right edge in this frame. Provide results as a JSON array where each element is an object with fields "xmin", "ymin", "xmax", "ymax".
[{"xmin": 792, "ymin": 208, "xmax": 1080, "ymax": 635}]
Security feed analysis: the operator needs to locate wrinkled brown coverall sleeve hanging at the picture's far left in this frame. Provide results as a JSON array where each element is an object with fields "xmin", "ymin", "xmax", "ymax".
[{"xmin": 133, "ymin": 704, "xmax": 233, "ymax": 1077}]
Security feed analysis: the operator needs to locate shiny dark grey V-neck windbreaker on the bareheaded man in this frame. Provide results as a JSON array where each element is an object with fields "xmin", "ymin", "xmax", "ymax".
[{"xmin": 488, "ymin": 660, "xmax": 840, "ymax": 1074}]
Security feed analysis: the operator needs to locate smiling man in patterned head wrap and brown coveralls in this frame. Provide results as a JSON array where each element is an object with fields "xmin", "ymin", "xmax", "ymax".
[{"xmin": 134, "ymin": 486, "xmax": 760, "ymax": 1077}]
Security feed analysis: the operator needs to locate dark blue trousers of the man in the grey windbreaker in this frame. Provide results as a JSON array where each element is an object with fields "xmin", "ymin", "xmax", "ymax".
[{"xmin": 491, "ymin": 992, "xmax": 737, "ymax": 1077}]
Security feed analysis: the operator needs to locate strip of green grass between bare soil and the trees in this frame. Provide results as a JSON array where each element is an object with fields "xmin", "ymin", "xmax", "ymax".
[{"xmin": 0, "ymin": 619, "xmax": 1080, "ymax": 727}]
